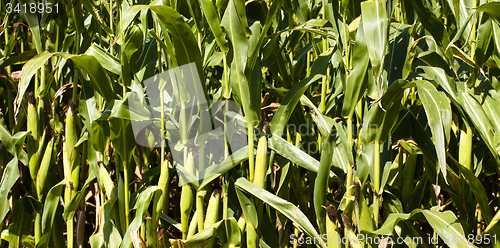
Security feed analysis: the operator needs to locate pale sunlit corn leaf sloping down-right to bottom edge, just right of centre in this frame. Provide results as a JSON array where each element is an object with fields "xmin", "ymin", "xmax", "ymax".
[{"xmin": 234, "ymin": 178, "xmax": 326, "ymax": 248}]
